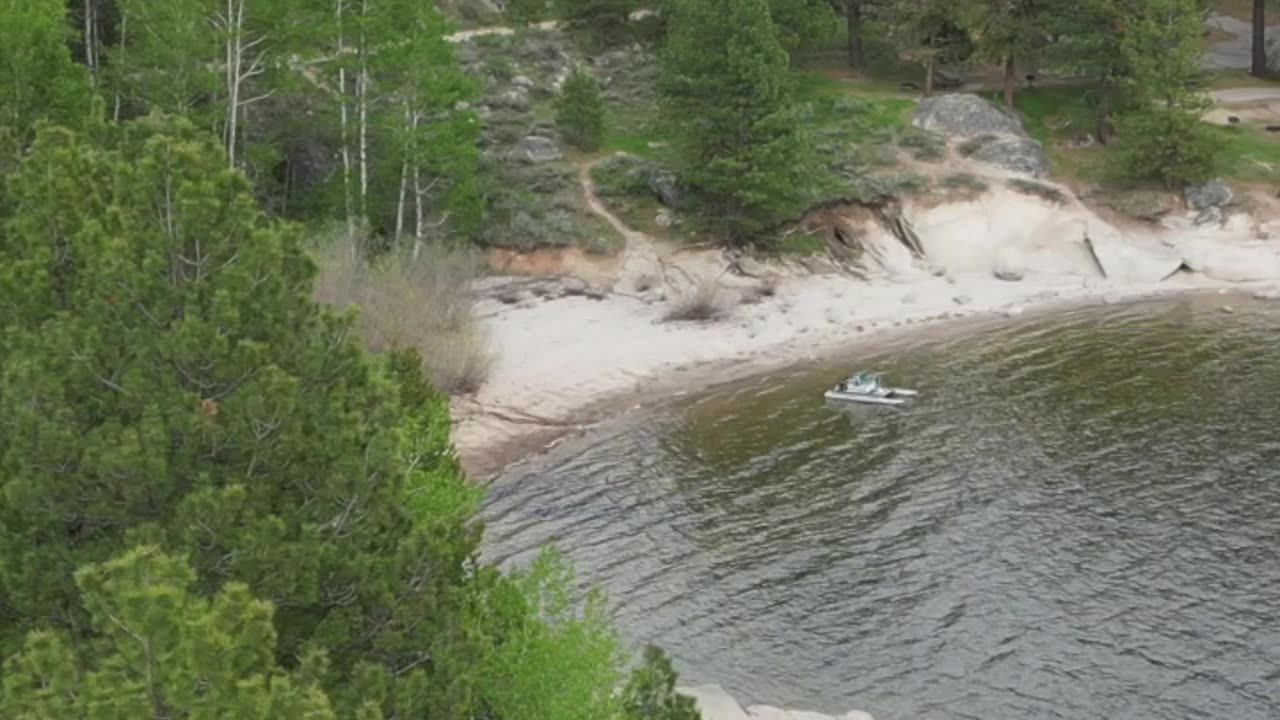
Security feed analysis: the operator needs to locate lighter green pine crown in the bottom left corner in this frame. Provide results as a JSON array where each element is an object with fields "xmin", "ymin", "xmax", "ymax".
[{"xmin": 0, "ymin": 546, "xmax": 337, "ymax": 720}]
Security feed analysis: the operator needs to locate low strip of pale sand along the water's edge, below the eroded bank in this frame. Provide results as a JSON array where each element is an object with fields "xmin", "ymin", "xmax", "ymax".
[{"xmin": 453, "ymin": 273, "xmax": 1276, "ymax": 476}]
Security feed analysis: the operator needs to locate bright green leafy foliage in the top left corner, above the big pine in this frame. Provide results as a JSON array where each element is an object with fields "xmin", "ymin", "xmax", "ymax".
[{"xmin": 0, "ymin": 0, "xmax": 93, "ymax": 146}]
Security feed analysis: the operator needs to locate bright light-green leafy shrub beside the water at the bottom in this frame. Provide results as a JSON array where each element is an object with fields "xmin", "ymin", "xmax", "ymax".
[{"xmin": 474, "ymin": 550, "xmax": 622, "ymax": 720}]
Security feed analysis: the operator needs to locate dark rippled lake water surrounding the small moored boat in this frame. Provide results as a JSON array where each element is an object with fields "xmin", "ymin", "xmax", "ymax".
[{"xmin": 486, "ymin": 296, "xmax": 1280, "ymax": 720}]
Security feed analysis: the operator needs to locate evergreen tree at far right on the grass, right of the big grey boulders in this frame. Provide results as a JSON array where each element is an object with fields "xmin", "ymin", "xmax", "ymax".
[{"xmin": 1117, "ymin": 0, "xmax": 1215, "ymax": 187}]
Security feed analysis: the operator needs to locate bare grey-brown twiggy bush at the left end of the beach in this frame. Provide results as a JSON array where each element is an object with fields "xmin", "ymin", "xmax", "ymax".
[{"xmin": 316, "ymin": 234, "xmax": 493, "ymax": 395}]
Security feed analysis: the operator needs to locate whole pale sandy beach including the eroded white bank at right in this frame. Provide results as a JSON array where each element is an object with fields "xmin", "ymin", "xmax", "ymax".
[{"xmin": 454, "ymin": 183, "xmax": 1280, "ymax": 479}]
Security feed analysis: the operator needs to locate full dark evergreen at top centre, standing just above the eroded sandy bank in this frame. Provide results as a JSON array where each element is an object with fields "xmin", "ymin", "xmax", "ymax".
[{"xmin": 659, "ymin": 0, "xmax": 817, "ymax": 241}]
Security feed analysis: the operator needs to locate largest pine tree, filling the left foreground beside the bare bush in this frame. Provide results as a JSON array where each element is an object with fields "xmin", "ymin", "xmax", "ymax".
[{"xmin": 0, "ymin": 117, "xmax": 477, "ymax": 717}]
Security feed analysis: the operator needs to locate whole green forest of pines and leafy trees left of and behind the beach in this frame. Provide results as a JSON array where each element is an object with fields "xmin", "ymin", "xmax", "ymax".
[{"xmin": 0, "ymin": 0, "xmax": 1267, "ymax": 720}]
